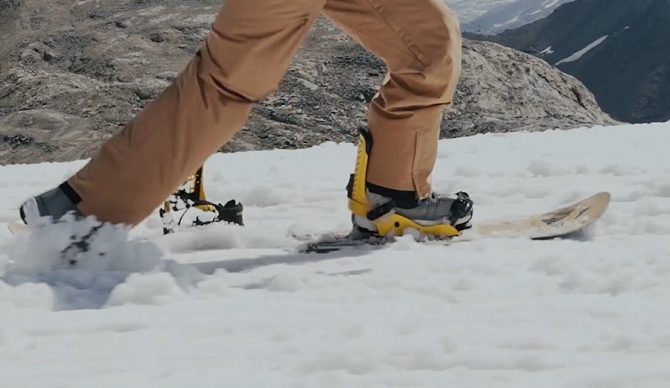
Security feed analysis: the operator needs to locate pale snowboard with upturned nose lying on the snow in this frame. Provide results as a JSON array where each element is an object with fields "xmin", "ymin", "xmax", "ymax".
[{"xmin": 301, "ymin": 192, "xmax": 611, "ymax": 253}]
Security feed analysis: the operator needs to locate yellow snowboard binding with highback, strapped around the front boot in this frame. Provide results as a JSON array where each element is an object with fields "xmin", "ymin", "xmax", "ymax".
[{"xmin": 347, "ymin": 129, "xmax": 469, "ymax": 238}]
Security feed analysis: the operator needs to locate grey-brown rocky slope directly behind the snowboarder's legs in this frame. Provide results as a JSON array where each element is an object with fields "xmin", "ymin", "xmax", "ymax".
[{"xmin": 0, "ymin": 0, "xmax": 613, "ymax": 164}]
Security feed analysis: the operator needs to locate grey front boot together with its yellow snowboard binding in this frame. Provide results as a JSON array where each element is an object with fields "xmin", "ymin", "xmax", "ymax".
[{"xmin": 347, "ymin": 130, "xmax": 473, "ymax": 238}]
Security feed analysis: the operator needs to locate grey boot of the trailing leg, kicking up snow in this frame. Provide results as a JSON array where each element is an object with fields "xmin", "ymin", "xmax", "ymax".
[{"xmin": 19, "ymin": 182, "xmax": 84, "ymax": 225}]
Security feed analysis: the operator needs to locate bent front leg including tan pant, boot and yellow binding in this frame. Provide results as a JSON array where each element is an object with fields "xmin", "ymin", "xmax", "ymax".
[{"xmin": 324, "ymin": 0, "xmax": 473, "ymax": 237}]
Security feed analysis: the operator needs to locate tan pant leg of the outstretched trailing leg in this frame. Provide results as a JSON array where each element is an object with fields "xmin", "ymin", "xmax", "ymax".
[{"xmin": 68, "ymin": 0, "xmax": 325, "ymax": 225}]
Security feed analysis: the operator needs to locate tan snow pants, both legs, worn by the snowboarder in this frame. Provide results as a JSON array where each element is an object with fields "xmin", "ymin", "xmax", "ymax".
[{"xmin": 68, "ymin": 0, "xmax": 468, "ymax": 225}]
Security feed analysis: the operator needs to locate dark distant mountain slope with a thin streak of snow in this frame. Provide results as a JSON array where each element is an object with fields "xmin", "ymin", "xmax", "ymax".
[{"xmin": 485, "ymin": 0, "xmax": 670, "ymax": 122}]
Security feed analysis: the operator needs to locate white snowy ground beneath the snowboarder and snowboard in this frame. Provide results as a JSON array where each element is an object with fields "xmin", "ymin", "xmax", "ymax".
[{"xmin": 0, "ymin": 123, "xmax": 670, "ymax": 388}]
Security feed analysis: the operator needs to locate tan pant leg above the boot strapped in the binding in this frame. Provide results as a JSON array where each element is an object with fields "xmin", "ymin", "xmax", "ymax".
[{"xmin": 324, "ymin": 0, "xmax": 461, "ymax": 198}]
